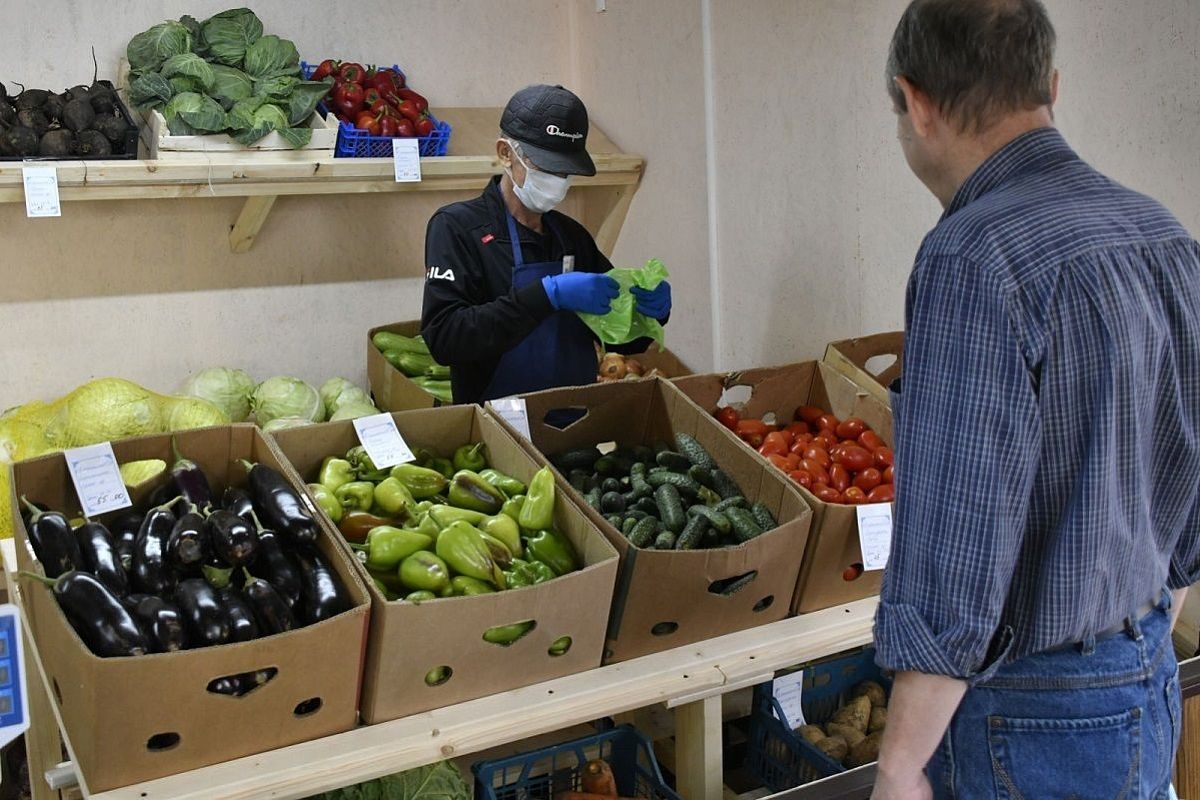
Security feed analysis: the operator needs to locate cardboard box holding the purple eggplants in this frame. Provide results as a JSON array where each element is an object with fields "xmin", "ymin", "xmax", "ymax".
[{"xmin": 12, "ymin": 425, "xmax": 370, "ymax": 792}]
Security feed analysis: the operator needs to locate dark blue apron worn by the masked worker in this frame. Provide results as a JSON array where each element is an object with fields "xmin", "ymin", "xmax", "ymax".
[{"xmin": 482, "ymin": 212, "xmax": 596, "ymax": 401}]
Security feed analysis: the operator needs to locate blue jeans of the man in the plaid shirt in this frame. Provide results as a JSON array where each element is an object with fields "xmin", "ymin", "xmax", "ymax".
[{"xmin": 926, "ymin": 593, "xmax": 1181, "ymax": 800}]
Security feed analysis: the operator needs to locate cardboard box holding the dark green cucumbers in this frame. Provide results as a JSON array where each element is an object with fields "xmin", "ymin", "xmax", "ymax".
[{"xmin": 492, "ymin": 378, "xmax": 811, "ymax": 662}]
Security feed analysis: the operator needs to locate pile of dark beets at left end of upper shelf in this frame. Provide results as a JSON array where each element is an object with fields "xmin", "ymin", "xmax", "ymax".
[{"xmin": 0, "ymin": 68, "xmax": 137, "ymax": 158}]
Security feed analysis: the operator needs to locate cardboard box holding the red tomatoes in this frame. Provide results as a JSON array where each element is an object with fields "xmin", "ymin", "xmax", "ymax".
[{"xmin": 676, "ymin": 361, "xmax": 892, "ymax": 614}]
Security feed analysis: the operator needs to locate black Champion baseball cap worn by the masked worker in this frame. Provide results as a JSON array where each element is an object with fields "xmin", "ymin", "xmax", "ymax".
[{"xmin": 500, "ymin": 84, "xmax": 596, "ymax": 175}]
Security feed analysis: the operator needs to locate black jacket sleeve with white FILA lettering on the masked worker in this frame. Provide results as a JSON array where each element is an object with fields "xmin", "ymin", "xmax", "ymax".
[{"xmin": 421, "ymin": 213, "xmax": 553, "ymax": 367}]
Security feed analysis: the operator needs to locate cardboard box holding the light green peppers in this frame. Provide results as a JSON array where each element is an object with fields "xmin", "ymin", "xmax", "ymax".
[{"xmin": 266, "ymin": 405, "xmax": 617, "ymax": 723}]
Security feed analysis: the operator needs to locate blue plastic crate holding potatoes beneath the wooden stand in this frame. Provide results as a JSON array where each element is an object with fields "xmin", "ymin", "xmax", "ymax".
[{"xmin": 746, "ymin": 648, "xmax": 892, "ymax": 792}]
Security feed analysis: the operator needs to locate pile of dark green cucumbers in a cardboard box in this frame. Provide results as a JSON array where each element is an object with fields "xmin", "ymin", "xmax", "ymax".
[{"xmin": 550, "ymin": 433, "xmax": 778, "ymax": 551}]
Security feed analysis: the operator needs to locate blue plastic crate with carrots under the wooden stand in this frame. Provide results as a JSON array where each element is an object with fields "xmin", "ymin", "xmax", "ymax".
[{"xmin": 472, "ymin": 726, "xmax": 682, "ymax": 800}]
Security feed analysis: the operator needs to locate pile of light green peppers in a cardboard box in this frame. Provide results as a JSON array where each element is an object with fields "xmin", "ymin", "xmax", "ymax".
[{"xmin": 308, "ymin": 443, "xmax": 580, "ymax": 602}]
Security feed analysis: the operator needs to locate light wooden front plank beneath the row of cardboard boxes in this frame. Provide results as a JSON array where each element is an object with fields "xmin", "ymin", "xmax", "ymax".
[{"xmin": 46, "ymin": 597, "xmax": 876, "ymax": 800}]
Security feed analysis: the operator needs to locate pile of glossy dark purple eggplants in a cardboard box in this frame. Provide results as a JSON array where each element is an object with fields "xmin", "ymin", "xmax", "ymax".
[{"xmin": 22, "ymin": 443, "xmax": 352, "ymax": 676}]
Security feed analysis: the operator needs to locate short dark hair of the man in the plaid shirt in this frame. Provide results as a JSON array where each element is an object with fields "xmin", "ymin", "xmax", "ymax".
[{"xmin": 887, "ymin": 0, "xmax": 1055, "ymax": 133}]
